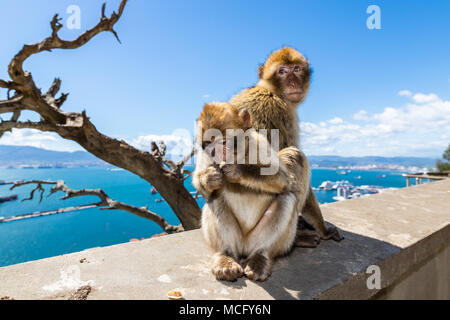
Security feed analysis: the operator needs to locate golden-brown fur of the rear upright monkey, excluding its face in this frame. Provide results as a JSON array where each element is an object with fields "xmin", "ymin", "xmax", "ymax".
[{"xmin": 230, "ymin": 47, "xmax": 342, "ymax": 241}]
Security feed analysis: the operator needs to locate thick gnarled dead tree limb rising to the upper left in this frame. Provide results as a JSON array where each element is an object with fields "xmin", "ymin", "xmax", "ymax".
[{"xmin": 0, "ymin": 0, "xmax": 201, "ymax": 230}]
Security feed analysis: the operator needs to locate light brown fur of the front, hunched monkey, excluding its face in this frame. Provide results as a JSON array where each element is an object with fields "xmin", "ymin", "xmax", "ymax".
[{"xmin": 193, "ymin": 104, "xmax": 308, "ymax": 281}]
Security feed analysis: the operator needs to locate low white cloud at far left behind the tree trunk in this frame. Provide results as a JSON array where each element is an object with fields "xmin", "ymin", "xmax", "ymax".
[{"xmin": 0, "ymin": 129, "xmax": 83, "ymax": 151}]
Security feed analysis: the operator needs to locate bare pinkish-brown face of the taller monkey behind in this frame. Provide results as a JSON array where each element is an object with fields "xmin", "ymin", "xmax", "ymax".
[{"xmin": 273, "ymin": 64, "xmax": 310, "ymax": 105}]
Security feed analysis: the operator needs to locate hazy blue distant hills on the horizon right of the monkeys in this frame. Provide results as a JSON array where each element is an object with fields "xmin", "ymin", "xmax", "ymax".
[{"xmin": 308, "ymin": 156, "xmax": 436, "ymax": 167}]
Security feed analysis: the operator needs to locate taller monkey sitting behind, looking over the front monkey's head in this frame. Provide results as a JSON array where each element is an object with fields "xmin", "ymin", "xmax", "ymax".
[{"xmin": 209, "ymin": 47, "xmax": 343, "ymax": 242}]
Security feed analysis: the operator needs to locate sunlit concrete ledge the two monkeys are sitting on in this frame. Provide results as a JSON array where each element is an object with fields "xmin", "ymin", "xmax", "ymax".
[{"xmin": 0, "ymin": 179, "xmax": 450, "ymax": 300}]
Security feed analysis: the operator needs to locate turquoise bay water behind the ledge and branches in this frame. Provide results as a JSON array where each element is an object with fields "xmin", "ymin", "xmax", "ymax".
[{"xmin": 0, "ymin": 168, "xmax": 406, "ymax": 266}]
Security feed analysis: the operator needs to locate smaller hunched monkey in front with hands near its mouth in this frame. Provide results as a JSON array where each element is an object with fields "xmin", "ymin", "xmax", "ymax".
[{"xmin": 193, "ymin": 103, "xmax": 309, "ymax": 281}]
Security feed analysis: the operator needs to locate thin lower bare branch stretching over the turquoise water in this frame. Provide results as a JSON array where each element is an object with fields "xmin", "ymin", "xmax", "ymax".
[{"xmin": 10, "ymin": 180, "xmax": 183, "ymax": 233}]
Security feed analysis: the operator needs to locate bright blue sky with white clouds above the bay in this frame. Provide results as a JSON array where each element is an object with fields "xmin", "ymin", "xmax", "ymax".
[{"xmin": 0, "ymin": 0, "xmax": 450, "ymax": 157}]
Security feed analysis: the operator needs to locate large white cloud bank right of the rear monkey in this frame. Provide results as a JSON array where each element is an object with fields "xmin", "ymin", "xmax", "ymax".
[{"xmin": 300, "ymin": 90, "xmax": 450, "ymax": 157}]
